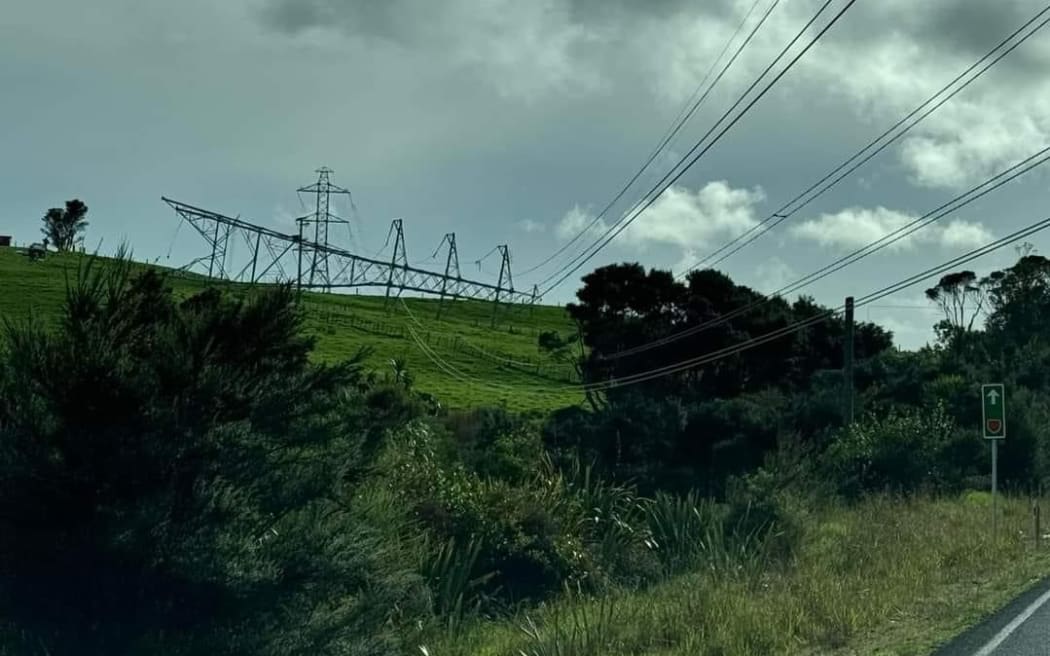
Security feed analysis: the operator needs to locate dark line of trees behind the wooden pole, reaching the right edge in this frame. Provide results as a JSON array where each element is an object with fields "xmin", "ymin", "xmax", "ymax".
[{"xmin": 540, "ymin": 258, "xmax": 1050, "ymax": 493}]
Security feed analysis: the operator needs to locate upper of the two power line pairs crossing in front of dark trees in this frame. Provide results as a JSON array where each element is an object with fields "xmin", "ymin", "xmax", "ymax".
[{"xmin": 605, "ymin": 139, "xmax": 1050, "ymax": 360}]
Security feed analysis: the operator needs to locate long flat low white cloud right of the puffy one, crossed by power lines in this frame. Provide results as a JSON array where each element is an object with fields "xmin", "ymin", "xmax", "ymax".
[{"xmin": 791, "ymin": 207, "xmax": 992, "ymax": 250}]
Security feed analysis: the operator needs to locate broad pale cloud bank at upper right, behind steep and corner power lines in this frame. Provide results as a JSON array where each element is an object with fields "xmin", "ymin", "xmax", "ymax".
[{"xmin": 637, "ymin": 0, "xmax": 1050, "ymax": 189}]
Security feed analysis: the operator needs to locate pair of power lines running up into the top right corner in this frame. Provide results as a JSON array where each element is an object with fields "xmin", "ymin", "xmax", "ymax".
[{"xmin": 676, "ymin": 5, "xmax": 1050, "ymax": 277}]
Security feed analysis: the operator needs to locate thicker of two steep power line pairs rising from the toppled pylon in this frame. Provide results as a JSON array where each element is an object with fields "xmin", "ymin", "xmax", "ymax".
[{"xmin": 541, "ymin": 0, "xmax": 857, "ymax": 296}]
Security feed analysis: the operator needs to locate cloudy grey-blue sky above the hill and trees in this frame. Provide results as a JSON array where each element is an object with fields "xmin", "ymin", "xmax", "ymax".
[{"xmin": 0, "ymin": 0, "xmax": 1050, "ymax": 348}]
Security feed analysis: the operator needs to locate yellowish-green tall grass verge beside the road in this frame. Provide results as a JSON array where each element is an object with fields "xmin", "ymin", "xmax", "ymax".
[{"xmin": 429, "ymin": 498, "xmax": 1050, "ymax": 656}]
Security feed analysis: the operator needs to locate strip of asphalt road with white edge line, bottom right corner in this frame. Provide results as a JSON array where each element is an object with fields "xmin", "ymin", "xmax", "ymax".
[{"xmin": 935, "ymin": 579, "xmax": 1050, "ymax": 656}]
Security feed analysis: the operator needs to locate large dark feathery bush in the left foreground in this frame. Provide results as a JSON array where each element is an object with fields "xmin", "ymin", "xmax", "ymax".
[{"xmin": 0, "ymin": 262, "xmax": 419, "ymax": 655}]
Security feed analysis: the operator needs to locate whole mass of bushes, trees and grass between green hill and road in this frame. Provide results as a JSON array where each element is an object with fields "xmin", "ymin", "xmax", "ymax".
[{"xmin": 0, "ymin": 246, "xmax": 1050, "ymax": 656}]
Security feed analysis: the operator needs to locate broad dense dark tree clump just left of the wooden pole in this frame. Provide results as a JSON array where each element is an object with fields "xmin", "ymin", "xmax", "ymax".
[{"xmin": 540, "ymin": 263, "xmax": 893, "ymax": 489}]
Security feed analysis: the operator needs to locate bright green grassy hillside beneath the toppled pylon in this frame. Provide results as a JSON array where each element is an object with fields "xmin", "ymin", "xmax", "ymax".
[{"xmin": 0, "ymin": 249, "xmax": 582, "ymax": 410}]
